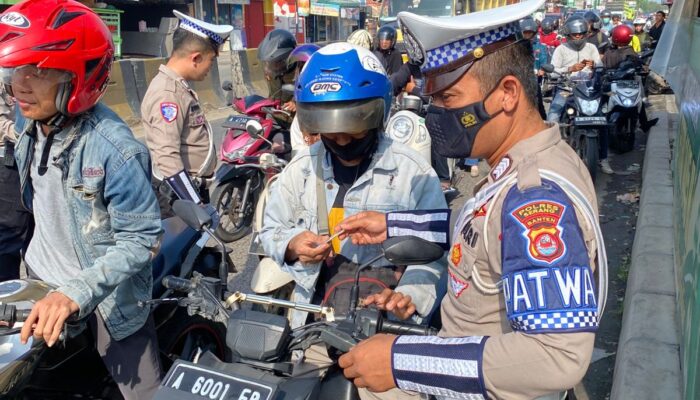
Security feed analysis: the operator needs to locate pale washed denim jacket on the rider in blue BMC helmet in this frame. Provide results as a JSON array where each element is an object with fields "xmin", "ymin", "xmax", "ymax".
[{"xmin": 260, "ymin": 136, "xmax": 447, "ymax": 327}]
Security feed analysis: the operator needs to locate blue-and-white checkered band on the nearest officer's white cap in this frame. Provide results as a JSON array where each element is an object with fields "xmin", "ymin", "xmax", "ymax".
[{"xmin": 422, "ymin": 21, "xmax": 520, "ymax": 72}]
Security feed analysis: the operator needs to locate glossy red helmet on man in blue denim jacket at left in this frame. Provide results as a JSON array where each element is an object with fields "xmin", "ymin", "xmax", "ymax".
[{"xmin": 0, "ymin": 0, "xmax": 114, "ymax": 116}]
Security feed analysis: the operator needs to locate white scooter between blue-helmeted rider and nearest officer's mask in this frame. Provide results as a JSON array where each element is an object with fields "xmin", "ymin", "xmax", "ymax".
[{"xmin": 386, "ymin": 94, "xmax": 457, "ymax": 196}]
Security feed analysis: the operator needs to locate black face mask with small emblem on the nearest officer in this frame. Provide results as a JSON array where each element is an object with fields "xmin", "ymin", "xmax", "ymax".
[{"xmin": 425, "ymin": 93, "xmax": 503, "ymax": 158}]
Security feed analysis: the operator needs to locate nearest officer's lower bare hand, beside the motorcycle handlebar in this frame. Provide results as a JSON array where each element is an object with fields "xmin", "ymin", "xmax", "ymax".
[{"xmin": 338, "ymin": 334, "xmax": 396, "ymax": 392}]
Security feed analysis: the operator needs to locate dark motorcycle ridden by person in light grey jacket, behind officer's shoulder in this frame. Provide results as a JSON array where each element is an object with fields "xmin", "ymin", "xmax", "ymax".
[{"xmin": 542, "ymin": 64, "xmax": 608, "ymax": 181}]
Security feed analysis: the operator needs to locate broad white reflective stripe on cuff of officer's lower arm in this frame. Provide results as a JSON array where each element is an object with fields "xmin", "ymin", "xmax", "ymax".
[{"xmin": 394, "ymin": 353, "xmax": 479, "ymax": 378}]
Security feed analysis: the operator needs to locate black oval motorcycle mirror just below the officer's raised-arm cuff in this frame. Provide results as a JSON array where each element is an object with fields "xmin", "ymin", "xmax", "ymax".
[{"xmin": 382, "ymin": 236, "xmax": 445, "ymax": 265}]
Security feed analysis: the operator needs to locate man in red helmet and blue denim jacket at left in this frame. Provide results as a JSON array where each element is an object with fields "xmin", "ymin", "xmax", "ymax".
[{"xmin": 0, "ymin": 0, "xmax": 161, "ymax": 399}]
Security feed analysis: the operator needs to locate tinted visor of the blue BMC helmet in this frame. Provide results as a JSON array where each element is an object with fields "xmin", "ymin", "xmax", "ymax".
[{"xmin": 297, "ymin": 98, "xmax": 384, "ymax": 135}]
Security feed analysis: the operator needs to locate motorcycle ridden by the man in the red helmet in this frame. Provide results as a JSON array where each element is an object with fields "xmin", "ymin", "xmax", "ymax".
[{"xmin": 0, "ymin": 205, "xmax": 233, "ymax": 399}]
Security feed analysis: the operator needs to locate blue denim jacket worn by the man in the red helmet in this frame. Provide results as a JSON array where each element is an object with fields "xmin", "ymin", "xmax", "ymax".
[{"xmin": 15, "ymin": 104, "xmax": 161, "ymax": 340}]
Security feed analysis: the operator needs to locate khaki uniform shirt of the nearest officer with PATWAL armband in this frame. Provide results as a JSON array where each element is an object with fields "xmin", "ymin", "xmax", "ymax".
[{"xmin": 439, "ymin": 125, "xmax": 598, "ymax": 399}]
